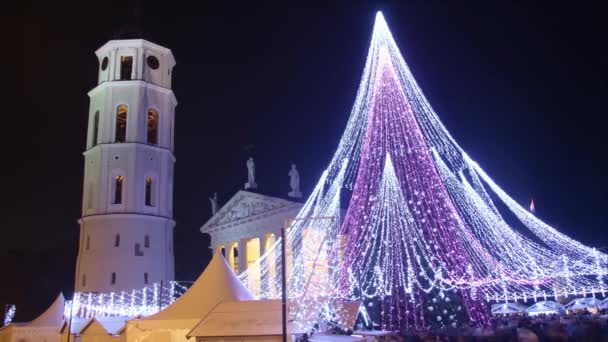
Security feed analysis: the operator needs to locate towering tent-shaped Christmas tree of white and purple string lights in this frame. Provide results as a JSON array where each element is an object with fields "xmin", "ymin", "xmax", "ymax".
[{"xmin": 239, "ymin": 12, "xmax": 608, "ymax": 330}]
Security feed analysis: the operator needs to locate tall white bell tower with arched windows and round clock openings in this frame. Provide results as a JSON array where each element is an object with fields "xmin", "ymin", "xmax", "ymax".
[{"xmin": 76, "ymin": 39, "xmax": 177, "ymax": 292}]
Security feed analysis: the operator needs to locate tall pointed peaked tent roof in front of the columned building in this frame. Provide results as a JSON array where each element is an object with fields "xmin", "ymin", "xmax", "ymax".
[{"xmin": 135, "ymin": 251, "xmax": 254, "ymax": 321}]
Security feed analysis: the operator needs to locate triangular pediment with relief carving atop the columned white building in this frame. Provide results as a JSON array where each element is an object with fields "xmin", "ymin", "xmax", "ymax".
[{"xmin": 201, "ymin": 190, "xmax": 299, "ymax": 233}]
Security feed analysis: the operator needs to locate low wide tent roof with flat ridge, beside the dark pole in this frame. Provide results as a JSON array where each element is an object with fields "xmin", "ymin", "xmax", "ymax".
[{"xmin": 187, "ymin": 299, "xmax": 304, "ymax": 337}]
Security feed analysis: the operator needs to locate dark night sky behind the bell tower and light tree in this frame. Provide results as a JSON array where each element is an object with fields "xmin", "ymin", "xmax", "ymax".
[{"xmin": 0, "ymin": 1, "xmax": 608, "ymax": 320}]
